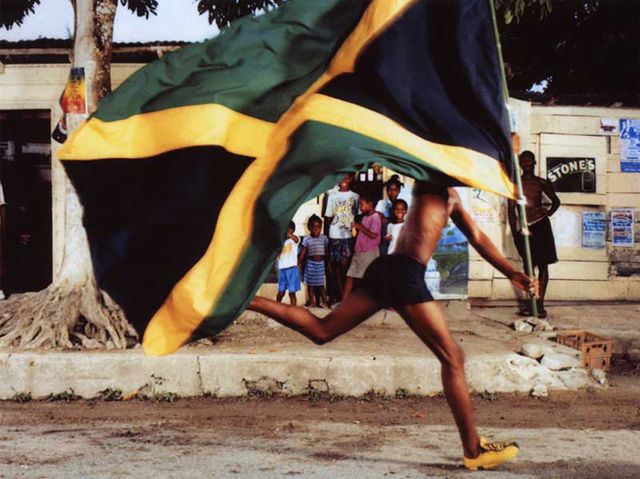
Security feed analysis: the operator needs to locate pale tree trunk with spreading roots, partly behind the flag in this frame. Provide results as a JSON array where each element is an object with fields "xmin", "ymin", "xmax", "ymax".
[{"xmin": 0, "ymin": 0, "xmax": 136, "ymax": 348}]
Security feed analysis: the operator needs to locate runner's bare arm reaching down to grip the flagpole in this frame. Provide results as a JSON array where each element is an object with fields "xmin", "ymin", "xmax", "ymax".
[{"xmin": 449, "ymin": 189, "xmax": 537, "ymax": 293}]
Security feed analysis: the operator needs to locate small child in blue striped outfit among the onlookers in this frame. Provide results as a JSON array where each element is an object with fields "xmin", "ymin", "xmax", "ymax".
[{"xmin": 299, "ymin": 215, "xmax": 329, "ymax": 307}]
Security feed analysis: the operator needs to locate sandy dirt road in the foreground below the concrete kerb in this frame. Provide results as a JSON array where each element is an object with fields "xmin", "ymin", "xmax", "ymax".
[{"xmin": 0, "ymin": 363, "xmax": 640, "ymax": 479}]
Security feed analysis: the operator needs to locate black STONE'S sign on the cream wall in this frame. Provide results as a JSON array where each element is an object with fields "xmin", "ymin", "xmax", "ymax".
[{"xmin": 547, "ymin": 156, "xmax": 596, "ymax": 193}]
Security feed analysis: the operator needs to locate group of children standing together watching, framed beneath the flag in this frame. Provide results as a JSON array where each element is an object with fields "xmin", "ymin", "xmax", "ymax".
[{"xmin": 276, "ymin": 174, "xmax": 408, "ymax": 307}]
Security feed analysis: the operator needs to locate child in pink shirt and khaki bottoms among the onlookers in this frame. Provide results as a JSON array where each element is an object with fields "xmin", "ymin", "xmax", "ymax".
[{"xmin": 344, "ymin": 195, "xmax": 382, "ymax": 299}]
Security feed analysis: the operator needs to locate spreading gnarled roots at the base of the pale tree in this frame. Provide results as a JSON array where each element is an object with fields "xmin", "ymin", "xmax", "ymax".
[{"xmin": 0, "ymin": 279, "xmax": 137, "ymax": 349}]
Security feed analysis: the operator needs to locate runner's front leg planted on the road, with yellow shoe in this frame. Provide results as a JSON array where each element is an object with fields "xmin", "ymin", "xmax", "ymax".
[{"xmin": 398, "ymin": 302, "xmax": 518, "ymax": 469}]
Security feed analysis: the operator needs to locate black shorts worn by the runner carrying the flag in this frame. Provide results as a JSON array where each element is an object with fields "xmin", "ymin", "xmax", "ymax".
[{"xmin": 356, "ymin": 254, "xmax": 433, "ymax": 308}]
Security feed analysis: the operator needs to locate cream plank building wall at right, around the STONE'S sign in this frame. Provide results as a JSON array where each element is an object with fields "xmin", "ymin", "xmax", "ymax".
[{"xmin": 469, "ymin": 101, "xmax": 640, "ymax": 301}]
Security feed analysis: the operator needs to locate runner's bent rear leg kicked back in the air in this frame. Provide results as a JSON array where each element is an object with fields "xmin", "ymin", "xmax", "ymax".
[{"xmin": 248, "ymin": 290, "xmax": 380, "ymax": 344}]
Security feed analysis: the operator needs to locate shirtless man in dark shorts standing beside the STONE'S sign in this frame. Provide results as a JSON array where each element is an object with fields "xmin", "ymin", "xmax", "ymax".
[{"xmin": 509, "ymin": 151, "xmax": 560, "ymax": 318}]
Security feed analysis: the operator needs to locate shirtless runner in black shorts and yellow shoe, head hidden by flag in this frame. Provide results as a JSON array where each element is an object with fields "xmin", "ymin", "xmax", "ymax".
[{"xmin": 249, "ymin": 182, "xmax": 537, "ymax": 470}]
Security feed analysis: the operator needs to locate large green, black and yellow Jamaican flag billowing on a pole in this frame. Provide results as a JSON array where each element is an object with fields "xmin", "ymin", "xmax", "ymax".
[{"xmin": 59, "ymin": 0, "xmax": 514, "ymax": 354}]
